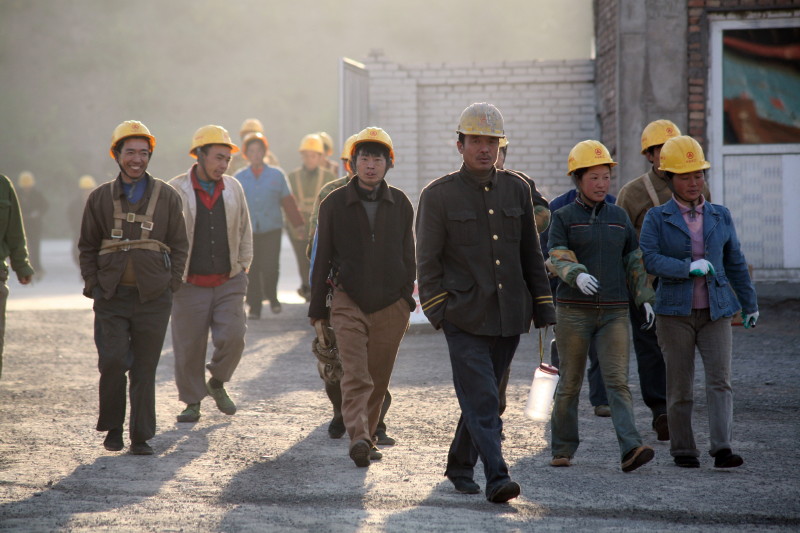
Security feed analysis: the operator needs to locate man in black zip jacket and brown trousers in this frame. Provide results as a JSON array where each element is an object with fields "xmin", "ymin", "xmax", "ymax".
[{"xmin": 308, "ymin": 127, "xmax": 416, "ymax": 467}]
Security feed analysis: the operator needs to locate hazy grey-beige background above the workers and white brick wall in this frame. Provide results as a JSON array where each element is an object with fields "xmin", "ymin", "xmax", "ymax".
[{"xmin": 0, "ymin": 0, "xmax": 593, "ymax": 238}]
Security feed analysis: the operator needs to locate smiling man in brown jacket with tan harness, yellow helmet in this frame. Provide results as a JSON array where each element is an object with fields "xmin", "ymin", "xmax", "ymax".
[{"xmin": 78, "ymin": 120, "xmax": 189, "ymax": 455}]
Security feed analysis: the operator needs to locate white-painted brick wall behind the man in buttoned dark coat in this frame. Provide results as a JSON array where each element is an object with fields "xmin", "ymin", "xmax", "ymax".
[{"xmin": 366, "ymin": 54, "xmax": 599, "ymax": 204}]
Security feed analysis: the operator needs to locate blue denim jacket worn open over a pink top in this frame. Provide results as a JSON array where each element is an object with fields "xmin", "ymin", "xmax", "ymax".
[{"xmin": 639, "ymin": 198, "xmax": 758, "ymax": 320}]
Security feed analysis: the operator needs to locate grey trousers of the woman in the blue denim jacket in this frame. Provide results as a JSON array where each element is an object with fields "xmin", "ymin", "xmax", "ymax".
[{"xmin": 656, "ymin": 309, "xmax": 733, "ymax": 457}]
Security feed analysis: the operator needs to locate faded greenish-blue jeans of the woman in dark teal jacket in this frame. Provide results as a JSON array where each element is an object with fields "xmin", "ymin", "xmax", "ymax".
[{"xmin": 551, "ymin": 306, "xmax": 642, "ymax": 457}]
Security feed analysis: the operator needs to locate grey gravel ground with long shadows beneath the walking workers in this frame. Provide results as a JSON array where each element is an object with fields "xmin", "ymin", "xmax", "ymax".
[{"xmin": 0, "ymin": 242, "xmax": 800, "ymax": 532}]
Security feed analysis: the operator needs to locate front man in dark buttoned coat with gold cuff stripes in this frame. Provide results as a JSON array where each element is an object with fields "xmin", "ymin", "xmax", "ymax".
[{"xmin": 416, "ymin": 103, "xmax": 555, "ymax": 503}]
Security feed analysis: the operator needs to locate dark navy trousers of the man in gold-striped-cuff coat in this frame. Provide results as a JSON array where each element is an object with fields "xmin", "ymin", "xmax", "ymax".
[{"xmin": 442, "ymin": 320, "xmax": 519, "ymax": 495}]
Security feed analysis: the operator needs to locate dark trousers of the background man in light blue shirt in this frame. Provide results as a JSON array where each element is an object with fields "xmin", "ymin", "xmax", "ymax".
[{"xmin": 247, "ymin": 228, "xmax": 282, "ymax": 313}]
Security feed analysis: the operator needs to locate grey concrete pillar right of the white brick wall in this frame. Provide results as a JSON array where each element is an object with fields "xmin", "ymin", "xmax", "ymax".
[{"xmin": 595, "ymin": 0, "xmax": 688, "ymax": 190}]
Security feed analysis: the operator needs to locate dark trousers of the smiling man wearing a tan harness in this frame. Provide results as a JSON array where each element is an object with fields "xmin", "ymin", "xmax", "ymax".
[{"xmin": 94, "ymin": 286, "xmax": 172, "ymax": 442}]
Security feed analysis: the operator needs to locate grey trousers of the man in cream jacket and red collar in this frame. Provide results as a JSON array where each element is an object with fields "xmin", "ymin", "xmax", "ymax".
[{"xmin": 172, "ymin": 272, "xmax": 247, "ymax": 404}]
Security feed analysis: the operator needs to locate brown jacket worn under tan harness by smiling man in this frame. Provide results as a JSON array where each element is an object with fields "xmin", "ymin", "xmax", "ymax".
[{"xmin": 78, "ymin": 174, "xmax": 189, "ymax": 302}]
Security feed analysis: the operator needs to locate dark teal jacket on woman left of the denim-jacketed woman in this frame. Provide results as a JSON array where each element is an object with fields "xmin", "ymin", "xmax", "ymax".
[{"xmin": 548, "ymin": 196, "xmax": 653, "ymax": 308}]
